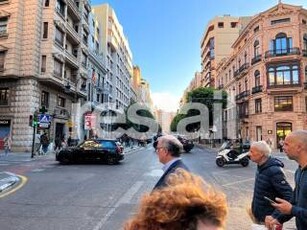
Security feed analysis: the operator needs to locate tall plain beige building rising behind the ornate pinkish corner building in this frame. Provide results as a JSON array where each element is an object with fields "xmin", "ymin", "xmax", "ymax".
[{"xmin": 200, "ymin": 15, "xmax": 250, "ymax": 87}]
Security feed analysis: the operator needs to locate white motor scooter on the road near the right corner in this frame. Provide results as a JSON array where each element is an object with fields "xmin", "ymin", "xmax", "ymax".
[{"xmin": 215, "ymin": 141, "xmax": 249, "ymax": 167}]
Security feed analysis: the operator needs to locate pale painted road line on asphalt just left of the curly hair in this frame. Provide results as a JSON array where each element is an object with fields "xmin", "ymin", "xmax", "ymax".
[{"xmin": 93, "ymin": 181, "xmax": 144, "ymax": 230}]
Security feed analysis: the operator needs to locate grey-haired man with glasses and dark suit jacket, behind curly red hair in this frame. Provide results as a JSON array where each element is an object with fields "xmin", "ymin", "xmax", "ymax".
[{"xmin": 153, "ymin": 135, "xmax": 189, "ymax": 189}]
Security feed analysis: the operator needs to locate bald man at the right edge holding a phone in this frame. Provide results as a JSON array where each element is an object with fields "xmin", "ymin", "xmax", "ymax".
[{"xmin": 266, "ymin": 130, "xmax": 307, "ymax": 230}]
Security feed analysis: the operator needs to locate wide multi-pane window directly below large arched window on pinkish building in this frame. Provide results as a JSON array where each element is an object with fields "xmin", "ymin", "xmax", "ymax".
[{"xmin": 268, "ymin": 64, "xmax": 299, "ymax": 86}]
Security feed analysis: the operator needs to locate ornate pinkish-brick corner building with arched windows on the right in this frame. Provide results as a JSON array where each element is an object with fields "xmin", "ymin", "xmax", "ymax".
[{"xmin": 216, "ymin": 2, "xmax": 307, "ymax": 147}]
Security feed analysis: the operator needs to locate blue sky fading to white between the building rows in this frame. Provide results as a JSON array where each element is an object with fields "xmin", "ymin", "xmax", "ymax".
[{"xmin": 91, "ymin": 0, "xmax": 307, "ymax": 111}]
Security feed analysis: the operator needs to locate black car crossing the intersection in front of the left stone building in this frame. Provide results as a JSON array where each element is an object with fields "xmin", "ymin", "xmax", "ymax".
[{"xmin": 56, "ymin": 139, "xmax": 124, "ymax": 164}]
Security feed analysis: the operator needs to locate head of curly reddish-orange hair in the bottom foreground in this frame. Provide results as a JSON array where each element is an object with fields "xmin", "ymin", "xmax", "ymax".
[{"xmin": 124, "ymin": 169, "xmax": 228, "ymax": 230}]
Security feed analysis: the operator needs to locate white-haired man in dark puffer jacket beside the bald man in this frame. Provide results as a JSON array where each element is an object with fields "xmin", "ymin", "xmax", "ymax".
[{"xmin": 249, "ymin": 141, "xmax": 292, "ymax": 224}]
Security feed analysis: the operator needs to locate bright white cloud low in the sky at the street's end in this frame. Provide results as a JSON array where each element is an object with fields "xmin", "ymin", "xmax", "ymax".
[{"xmin": 151, "ymin": 92, "xmax": 180, "ymax": 112}]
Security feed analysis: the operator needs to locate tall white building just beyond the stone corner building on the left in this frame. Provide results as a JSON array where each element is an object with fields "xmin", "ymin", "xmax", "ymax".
[{"xmin": 93, "ymin": 4, "xmax": 133, "ymax": 111}]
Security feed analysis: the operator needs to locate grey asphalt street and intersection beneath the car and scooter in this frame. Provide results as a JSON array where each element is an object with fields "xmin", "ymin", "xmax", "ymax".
[{"xmin": 0, "ymin": 145, "xmax": 296, "ymax": 230}]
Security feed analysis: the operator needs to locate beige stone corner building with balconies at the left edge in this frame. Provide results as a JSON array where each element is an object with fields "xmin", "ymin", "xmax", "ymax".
[{"xmin": 0, "ymin": 0, "xmax": 95, "ymax": 151}]
